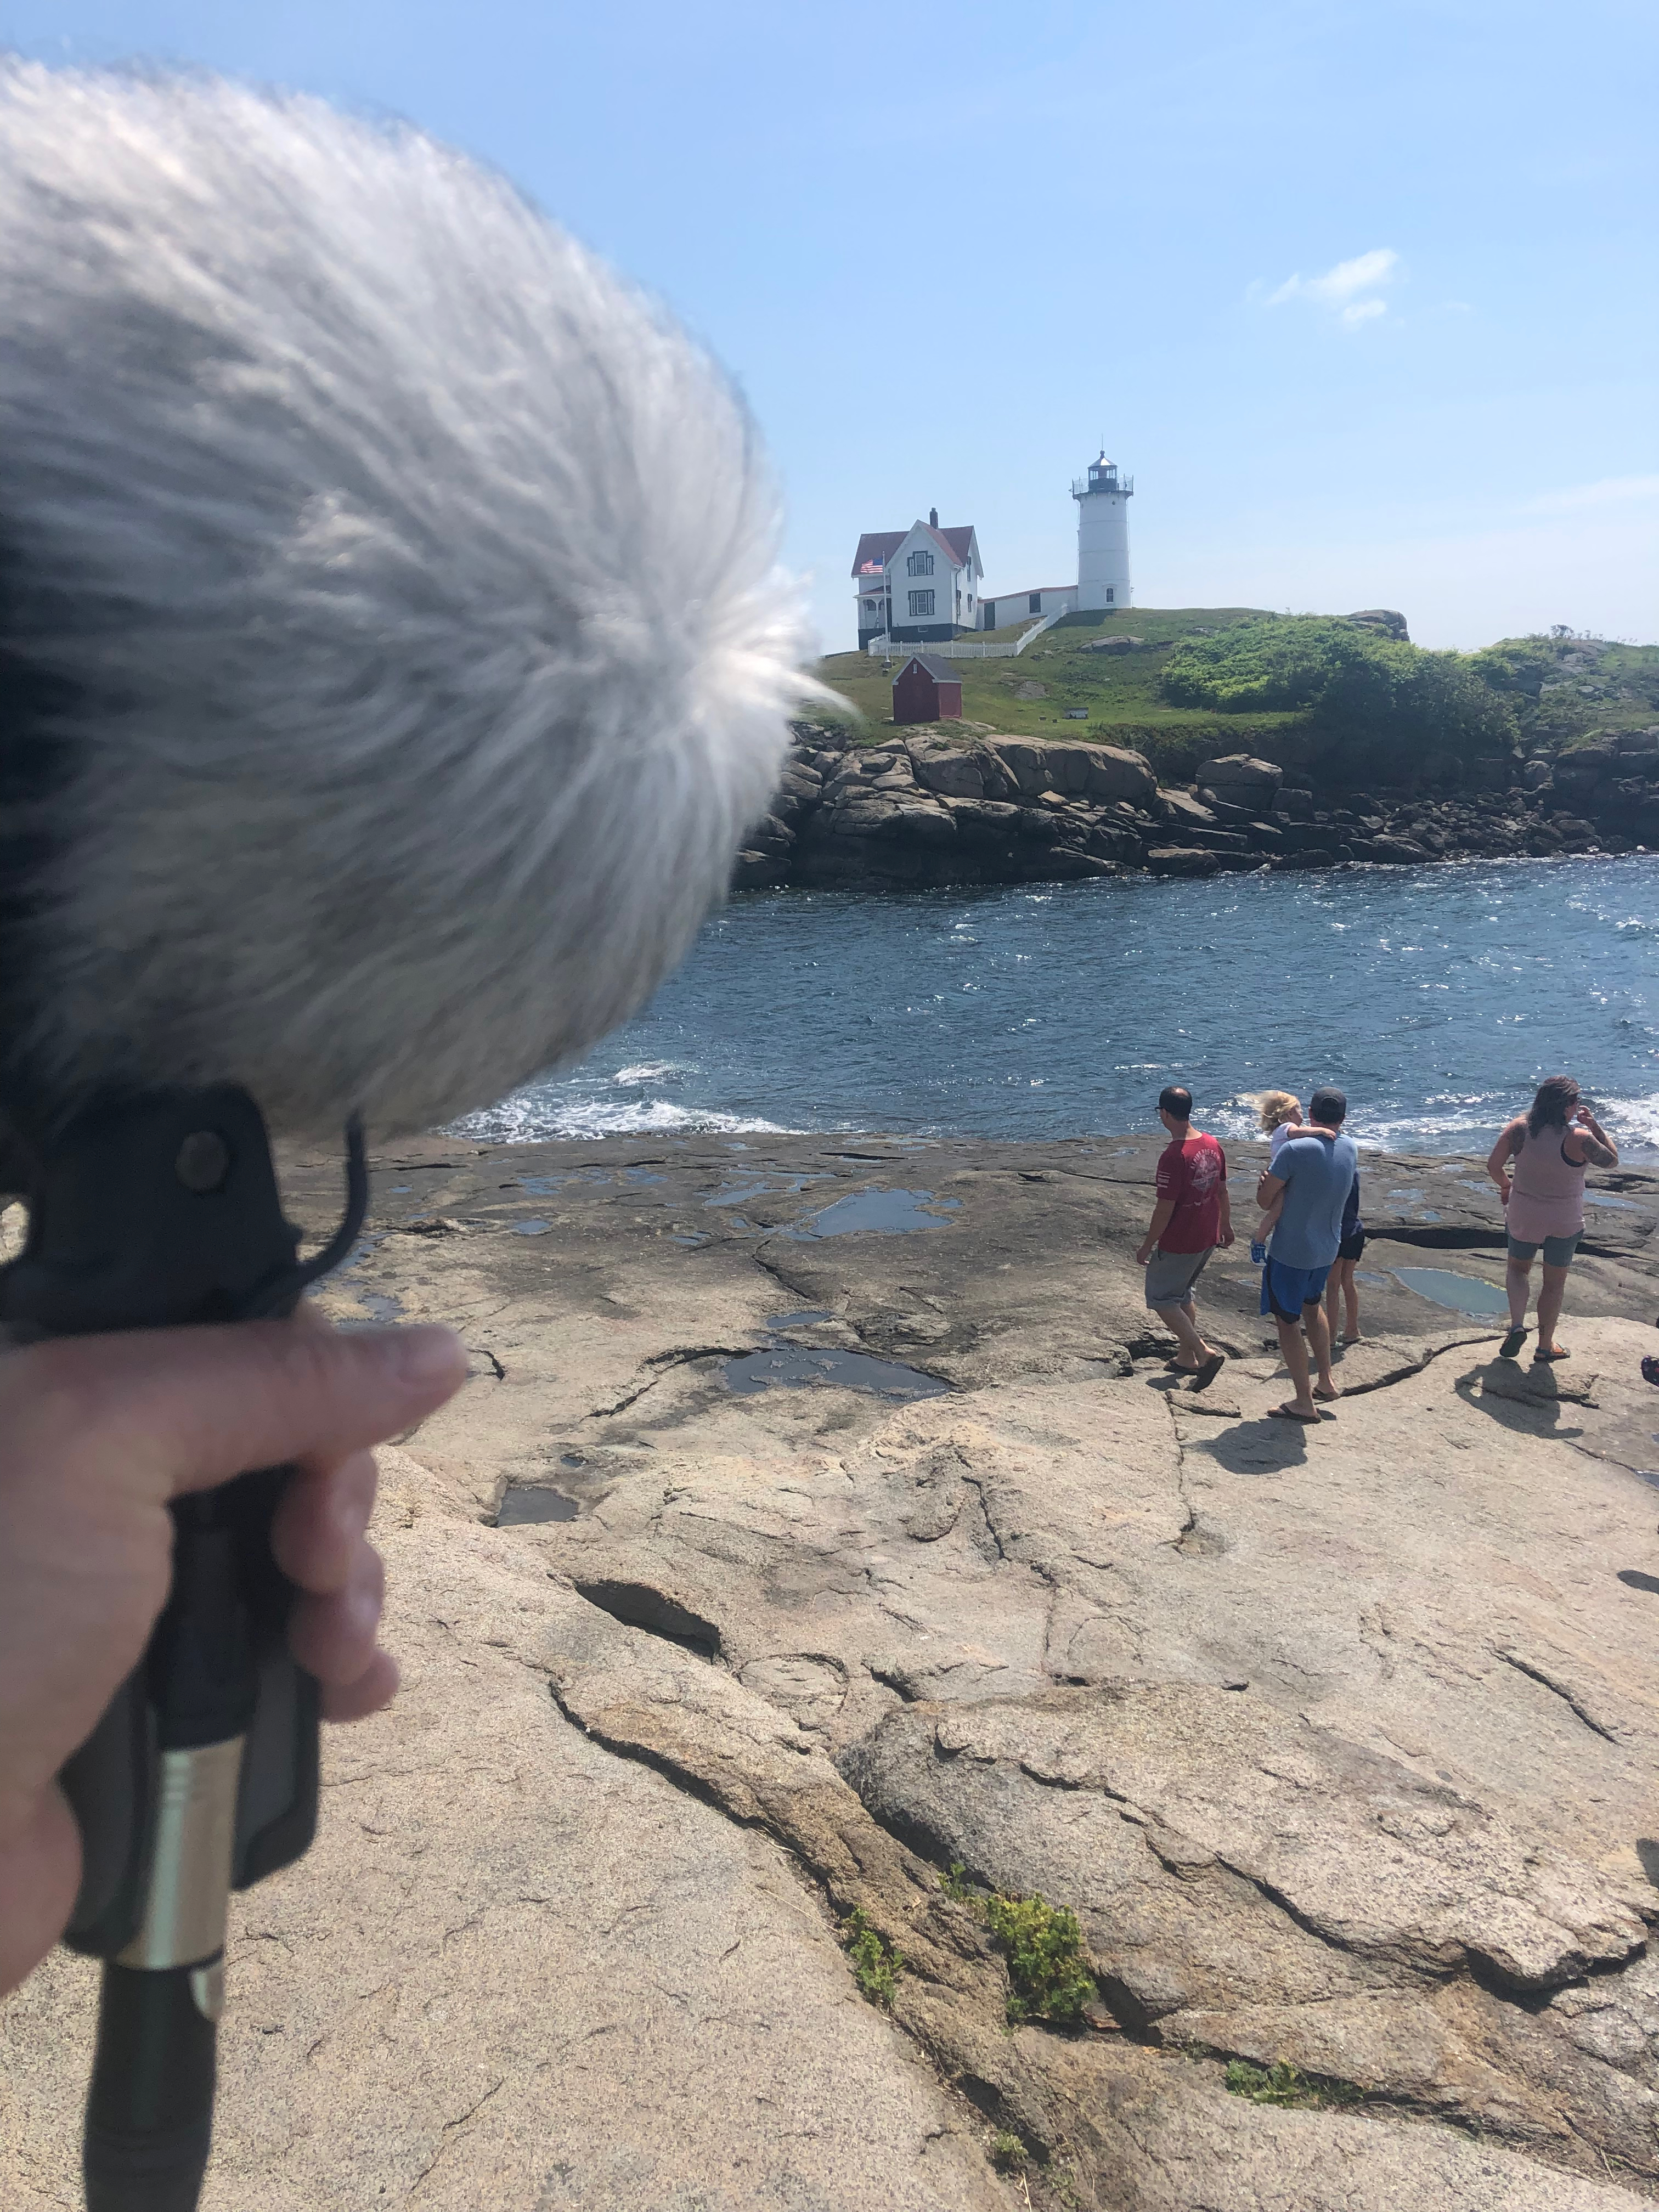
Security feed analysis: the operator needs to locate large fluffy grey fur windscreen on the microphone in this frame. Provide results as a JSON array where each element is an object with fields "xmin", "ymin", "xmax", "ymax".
[{"xmin": 0, "ymin": 66, "xmax": 812, "ymax": 1135}]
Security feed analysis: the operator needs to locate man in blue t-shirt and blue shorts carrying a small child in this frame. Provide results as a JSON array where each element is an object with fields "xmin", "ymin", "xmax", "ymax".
[{"xmin": 1256, "ymin": 1088, "xmax": 1361, "ymax": 1420}]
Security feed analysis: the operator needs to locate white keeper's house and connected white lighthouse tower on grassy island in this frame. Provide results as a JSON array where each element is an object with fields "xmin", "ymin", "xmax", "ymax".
[{"xmin": 851, "ymin": 454, "xmax": 1135, "ymax": 652}]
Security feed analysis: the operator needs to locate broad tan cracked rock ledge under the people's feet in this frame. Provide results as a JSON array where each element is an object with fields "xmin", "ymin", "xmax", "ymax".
[{"xmin": 0, "ymin": 1137, "xmax": 1659, "ymax": 2212}]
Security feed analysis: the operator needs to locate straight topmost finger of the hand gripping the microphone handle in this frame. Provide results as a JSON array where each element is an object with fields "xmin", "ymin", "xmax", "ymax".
[{"xmin": 0, "ymin": 1321, "xmax": 467, "ymax": 1502}]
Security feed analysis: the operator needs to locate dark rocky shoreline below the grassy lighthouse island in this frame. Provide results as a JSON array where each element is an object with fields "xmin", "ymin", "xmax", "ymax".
[{"xmin": 732, "ymin": 723, "xmax": 1659, "ymax": 891}]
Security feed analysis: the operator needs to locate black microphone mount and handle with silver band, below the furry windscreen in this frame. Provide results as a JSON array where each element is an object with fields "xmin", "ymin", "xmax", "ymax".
[{"xmin": 0, "ymin": 1084, "xmax": 367, "ymax": 2212}]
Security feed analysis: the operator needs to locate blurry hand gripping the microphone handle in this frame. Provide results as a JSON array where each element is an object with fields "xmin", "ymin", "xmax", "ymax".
[{"xmin": 0, "ymin": 1316, "xmax": 467, "ymax": 1991}]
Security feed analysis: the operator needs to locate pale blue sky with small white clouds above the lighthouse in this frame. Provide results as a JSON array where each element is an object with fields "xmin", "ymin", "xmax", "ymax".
[{"xmin": 0, "ymin": 0, "xmax": 1659, "ymax": 648}]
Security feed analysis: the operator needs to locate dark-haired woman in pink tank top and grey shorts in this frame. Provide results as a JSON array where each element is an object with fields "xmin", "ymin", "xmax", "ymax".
[{"xmin": 1487, "ymin": 1075, "xmax": 1619, "ymax": 1363}]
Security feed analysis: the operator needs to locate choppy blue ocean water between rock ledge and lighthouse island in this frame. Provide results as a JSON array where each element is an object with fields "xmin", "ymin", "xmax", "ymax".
[{"xmin": 451, "ymin": 856, "xmax": 1659, "ymax": 1159}]
